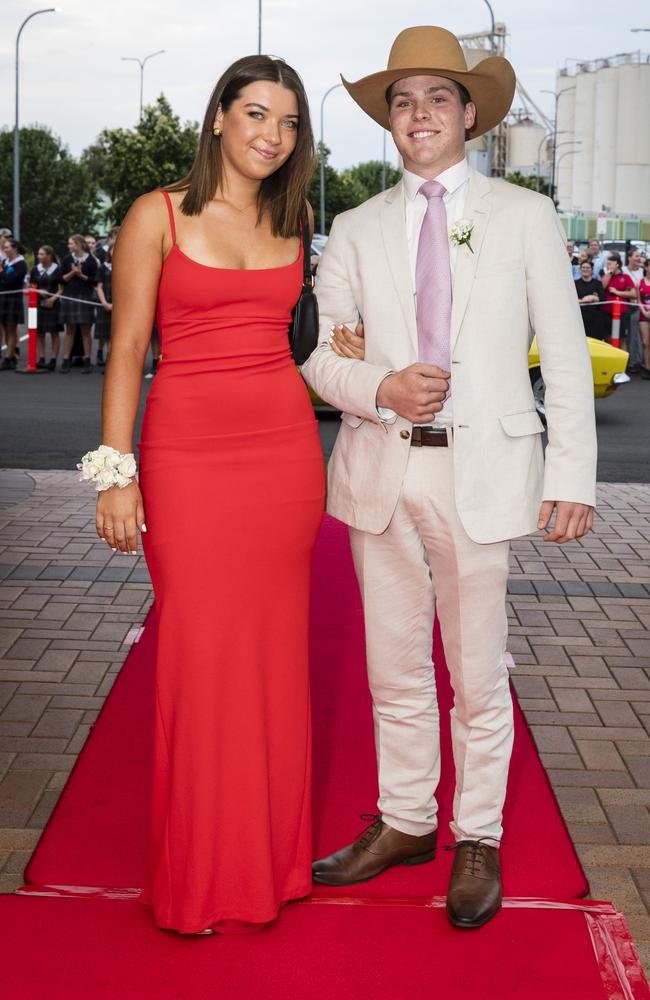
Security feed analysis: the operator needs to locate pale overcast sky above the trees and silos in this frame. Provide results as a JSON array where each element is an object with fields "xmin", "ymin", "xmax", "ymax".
[{"xmin": 0, "ymin": 0, "xmax": 650, "ymax": 169}]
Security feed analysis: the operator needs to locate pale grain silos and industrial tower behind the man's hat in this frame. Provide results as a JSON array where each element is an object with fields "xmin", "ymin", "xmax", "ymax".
[{"xmin": 461, "ymin": 31, "xmax": 650, "ymax": 241}]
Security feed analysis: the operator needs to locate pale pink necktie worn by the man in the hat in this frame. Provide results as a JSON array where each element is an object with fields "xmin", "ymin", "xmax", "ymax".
[{"xmin": 415, "ymin": 181, "xmax": 451, "ymax": 371}]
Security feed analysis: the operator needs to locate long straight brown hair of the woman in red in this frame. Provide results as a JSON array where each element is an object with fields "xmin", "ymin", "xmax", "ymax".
[{"xmin": 165, "ymin": 55, "xmax": 314, "ymax": 239}]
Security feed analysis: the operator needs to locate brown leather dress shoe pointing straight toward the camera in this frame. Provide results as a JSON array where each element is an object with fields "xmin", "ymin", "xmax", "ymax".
[{"xmin": 447, "ymin": 840, "xmax": 502, "ymax": 927}]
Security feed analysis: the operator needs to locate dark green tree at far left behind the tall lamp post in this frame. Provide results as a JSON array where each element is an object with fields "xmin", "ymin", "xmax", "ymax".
[{"xmin": 0, "ymin": 125, "xmax": 99, "ymax": 251}]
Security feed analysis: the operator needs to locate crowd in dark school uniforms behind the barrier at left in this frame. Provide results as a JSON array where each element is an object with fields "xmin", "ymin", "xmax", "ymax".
[{"xmin": 0, "ymin": 227, "xmax": 160, "ymax": 378}]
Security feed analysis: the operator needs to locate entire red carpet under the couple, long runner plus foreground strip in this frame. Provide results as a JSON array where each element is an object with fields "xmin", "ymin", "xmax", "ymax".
[{"xmin": 15, "ymin": 519, "xmax": 650, "ymax": 1000}]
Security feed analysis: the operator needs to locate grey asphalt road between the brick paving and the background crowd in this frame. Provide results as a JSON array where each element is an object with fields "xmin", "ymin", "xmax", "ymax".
[{"xmin": 0, "ymin": 368, "xmax": 650, "ymax": 483}]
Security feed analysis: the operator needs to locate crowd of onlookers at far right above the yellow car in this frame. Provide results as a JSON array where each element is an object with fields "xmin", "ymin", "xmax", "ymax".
[{"xmin": 567, "ymin": 239, "xmax": 650, "ymax": 379}]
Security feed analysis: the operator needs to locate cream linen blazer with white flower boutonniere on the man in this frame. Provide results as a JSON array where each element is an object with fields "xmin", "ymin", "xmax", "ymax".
[{"xmin": 302, "ymin": 170, "xmax": 596, "ymax": 543}]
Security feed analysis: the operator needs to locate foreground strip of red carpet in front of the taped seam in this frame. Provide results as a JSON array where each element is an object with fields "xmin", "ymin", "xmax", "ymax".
[{"xmin": 0, "ymin": 896, "xmax": 650, "ymax": 1000}]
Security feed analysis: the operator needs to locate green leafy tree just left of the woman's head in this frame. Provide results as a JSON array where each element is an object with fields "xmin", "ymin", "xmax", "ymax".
[{"xmin": 82, "ymin": 94, "xmax": 198, "ymax": 224}]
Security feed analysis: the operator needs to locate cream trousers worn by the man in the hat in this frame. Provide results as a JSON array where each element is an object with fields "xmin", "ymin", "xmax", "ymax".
[{"xmin": 350, "ymin": 445, "xmax": 513, "ymax": 840}]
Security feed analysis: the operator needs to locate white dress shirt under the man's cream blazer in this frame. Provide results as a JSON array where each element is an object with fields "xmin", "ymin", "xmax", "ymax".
[{"xmin": 377, "ymin": 158, "xmax": 469, "ymax": 427}]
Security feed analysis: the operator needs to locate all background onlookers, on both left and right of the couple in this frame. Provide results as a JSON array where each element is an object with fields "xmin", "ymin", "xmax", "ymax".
[{"xmin": 0, "ymin": 227, "xmax": 650, "ymax": 379}]
